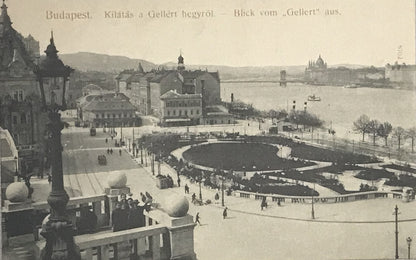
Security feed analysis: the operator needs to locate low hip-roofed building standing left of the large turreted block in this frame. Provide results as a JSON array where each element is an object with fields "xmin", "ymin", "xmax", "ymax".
[{"xmin": 78, "ymin": 92, "xmax": 140, "ymax": 127}]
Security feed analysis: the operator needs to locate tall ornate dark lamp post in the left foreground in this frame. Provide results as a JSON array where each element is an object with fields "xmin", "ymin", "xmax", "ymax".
[{"xmin": 34, "ymin": 34, "xmax": 81, "ymax": 260}]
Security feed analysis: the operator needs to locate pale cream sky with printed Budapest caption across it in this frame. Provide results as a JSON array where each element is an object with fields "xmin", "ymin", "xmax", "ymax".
[{"xmin": 6, "ymin": 0, "xmax": 415, "ymax": 66}]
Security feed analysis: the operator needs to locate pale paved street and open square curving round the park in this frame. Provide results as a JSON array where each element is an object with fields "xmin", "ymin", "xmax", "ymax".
[{"xmin": 20, "ymin": 128, "xmax": 416, "ymax": 260}]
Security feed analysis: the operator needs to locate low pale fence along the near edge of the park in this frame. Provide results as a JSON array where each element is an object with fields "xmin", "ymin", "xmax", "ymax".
[{"xmin": 233, "ymin": 190, "xmax": 409, "ymax": 204}]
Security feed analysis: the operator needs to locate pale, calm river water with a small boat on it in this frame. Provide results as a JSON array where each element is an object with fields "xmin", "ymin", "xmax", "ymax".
[{"xmin": 221, "ymin": 82, "xmax": 416, "ymax": 138}]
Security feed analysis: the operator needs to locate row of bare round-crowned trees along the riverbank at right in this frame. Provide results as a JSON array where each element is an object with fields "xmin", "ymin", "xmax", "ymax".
[{"xmin": 353, "ymin": 115, "xmax": 416, "ymax": 153}]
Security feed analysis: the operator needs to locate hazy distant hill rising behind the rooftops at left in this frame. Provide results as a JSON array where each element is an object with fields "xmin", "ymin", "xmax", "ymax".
[{"xmin": 59, "ymin": 52, "xmax": 156, "ymax": 73}]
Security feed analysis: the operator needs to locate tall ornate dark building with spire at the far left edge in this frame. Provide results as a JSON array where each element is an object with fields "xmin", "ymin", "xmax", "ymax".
[{"xmin": 0, "ymin": 2, "xmax": 45, "ymax": 171}]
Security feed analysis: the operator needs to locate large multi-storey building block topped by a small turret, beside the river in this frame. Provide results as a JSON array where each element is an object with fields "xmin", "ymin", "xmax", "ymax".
[{"xmin": 116, "ymin": 55, "xmax": 233, "ymax": 124}]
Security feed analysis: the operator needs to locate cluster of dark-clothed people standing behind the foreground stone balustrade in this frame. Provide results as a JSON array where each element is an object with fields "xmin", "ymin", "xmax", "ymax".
[{"xmin": 111, "ymin": 192, "xmax": 153, "ymax": 232}]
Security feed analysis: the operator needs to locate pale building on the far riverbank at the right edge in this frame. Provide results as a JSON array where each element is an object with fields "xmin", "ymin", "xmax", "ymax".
[{"xmin": 386, "ymin": 62, "xmax": 416, "ymax": 89}]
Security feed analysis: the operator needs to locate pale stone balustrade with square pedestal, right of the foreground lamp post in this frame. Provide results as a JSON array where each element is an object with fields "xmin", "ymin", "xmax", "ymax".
[{"xmin": 36, "ymin": 209, "xmax": 196, "ymax": 260}]
